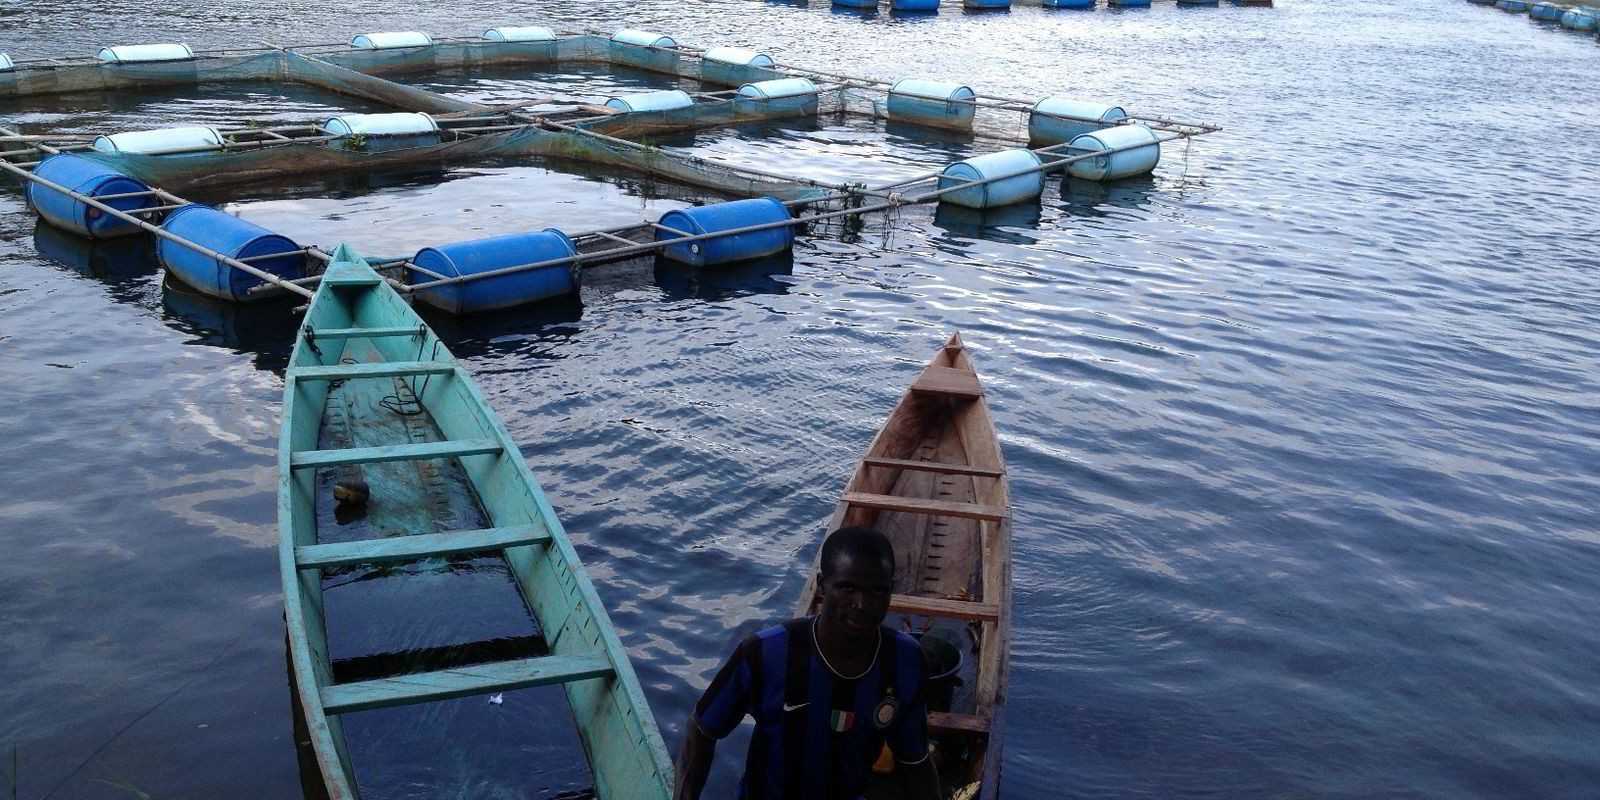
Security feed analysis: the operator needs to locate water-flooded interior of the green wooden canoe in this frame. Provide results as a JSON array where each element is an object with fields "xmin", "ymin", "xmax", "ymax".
[{"xmin": 280, "ymin": 252, "xmax": 670, "ymax": 798}]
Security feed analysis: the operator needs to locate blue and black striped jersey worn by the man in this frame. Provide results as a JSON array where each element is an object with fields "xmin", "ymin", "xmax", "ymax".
[{"xmin": 694, "ymin": 616, "xmax": 928, "ymax": 800}]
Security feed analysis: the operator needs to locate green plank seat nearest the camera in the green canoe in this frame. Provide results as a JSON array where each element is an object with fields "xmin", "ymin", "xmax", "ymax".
[{"xmin": 322, "ymin": 653, "xmax": 613, "ymax": 714}]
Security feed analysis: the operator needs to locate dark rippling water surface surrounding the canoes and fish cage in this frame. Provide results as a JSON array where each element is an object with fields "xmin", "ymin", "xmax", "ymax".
[{"xmin": 0, "ymin": 0, "xmax": 1600, "ymax": 800}]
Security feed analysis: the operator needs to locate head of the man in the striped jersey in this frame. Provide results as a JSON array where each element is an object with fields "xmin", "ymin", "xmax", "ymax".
[{"xmin": 819, "ymin": 528, "xmax": 894, "ymax": 645}]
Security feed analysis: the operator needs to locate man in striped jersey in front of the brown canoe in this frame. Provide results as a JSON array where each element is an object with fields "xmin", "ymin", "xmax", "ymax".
[{"xmin": 677, "ymin": 528, "xmax": 939, "ymax": 800}]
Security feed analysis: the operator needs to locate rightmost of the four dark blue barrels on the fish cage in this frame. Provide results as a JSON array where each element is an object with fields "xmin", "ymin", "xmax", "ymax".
[{"xmin": 656, "ymin": 197, "xmax": 795, "ymax": 267}]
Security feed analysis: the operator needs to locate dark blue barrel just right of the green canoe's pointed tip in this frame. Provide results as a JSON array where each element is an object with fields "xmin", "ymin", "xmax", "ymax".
[{"xmin": 411, "ymin": 227, "xmax": 579, "ymax": 314}]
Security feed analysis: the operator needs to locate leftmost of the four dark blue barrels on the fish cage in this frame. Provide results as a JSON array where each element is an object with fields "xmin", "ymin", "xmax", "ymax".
[{"xmin": 24, "ymin": 154, "xmax": 160, "ymax": 238}]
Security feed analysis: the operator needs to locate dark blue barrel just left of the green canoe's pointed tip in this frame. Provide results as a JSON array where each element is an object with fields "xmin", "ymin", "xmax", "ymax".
[{"xmin": 155, "ymin": 203, "xmax": 306, "ymax": 302}]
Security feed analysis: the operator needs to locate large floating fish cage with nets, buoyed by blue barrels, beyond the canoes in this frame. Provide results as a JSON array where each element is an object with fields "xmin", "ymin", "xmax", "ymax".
[{"xmin": 0, "ymin": 25, "xmax": 1219, "ymax": 314}]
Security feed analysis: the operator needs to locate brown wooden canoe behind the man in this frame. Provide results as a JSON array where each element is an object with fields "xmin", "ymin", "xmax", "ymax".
[{"xmin": 797, "ymin": 333, "xmax": 1011, "ymax": 798}]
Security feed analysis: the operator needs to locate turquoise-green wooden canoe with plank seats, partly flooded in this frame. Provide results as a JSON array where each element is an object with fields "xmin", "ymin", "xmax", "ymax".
[{"xmin": 278, "ymin": 246, "xmax": 672, "ymax": 800}]
